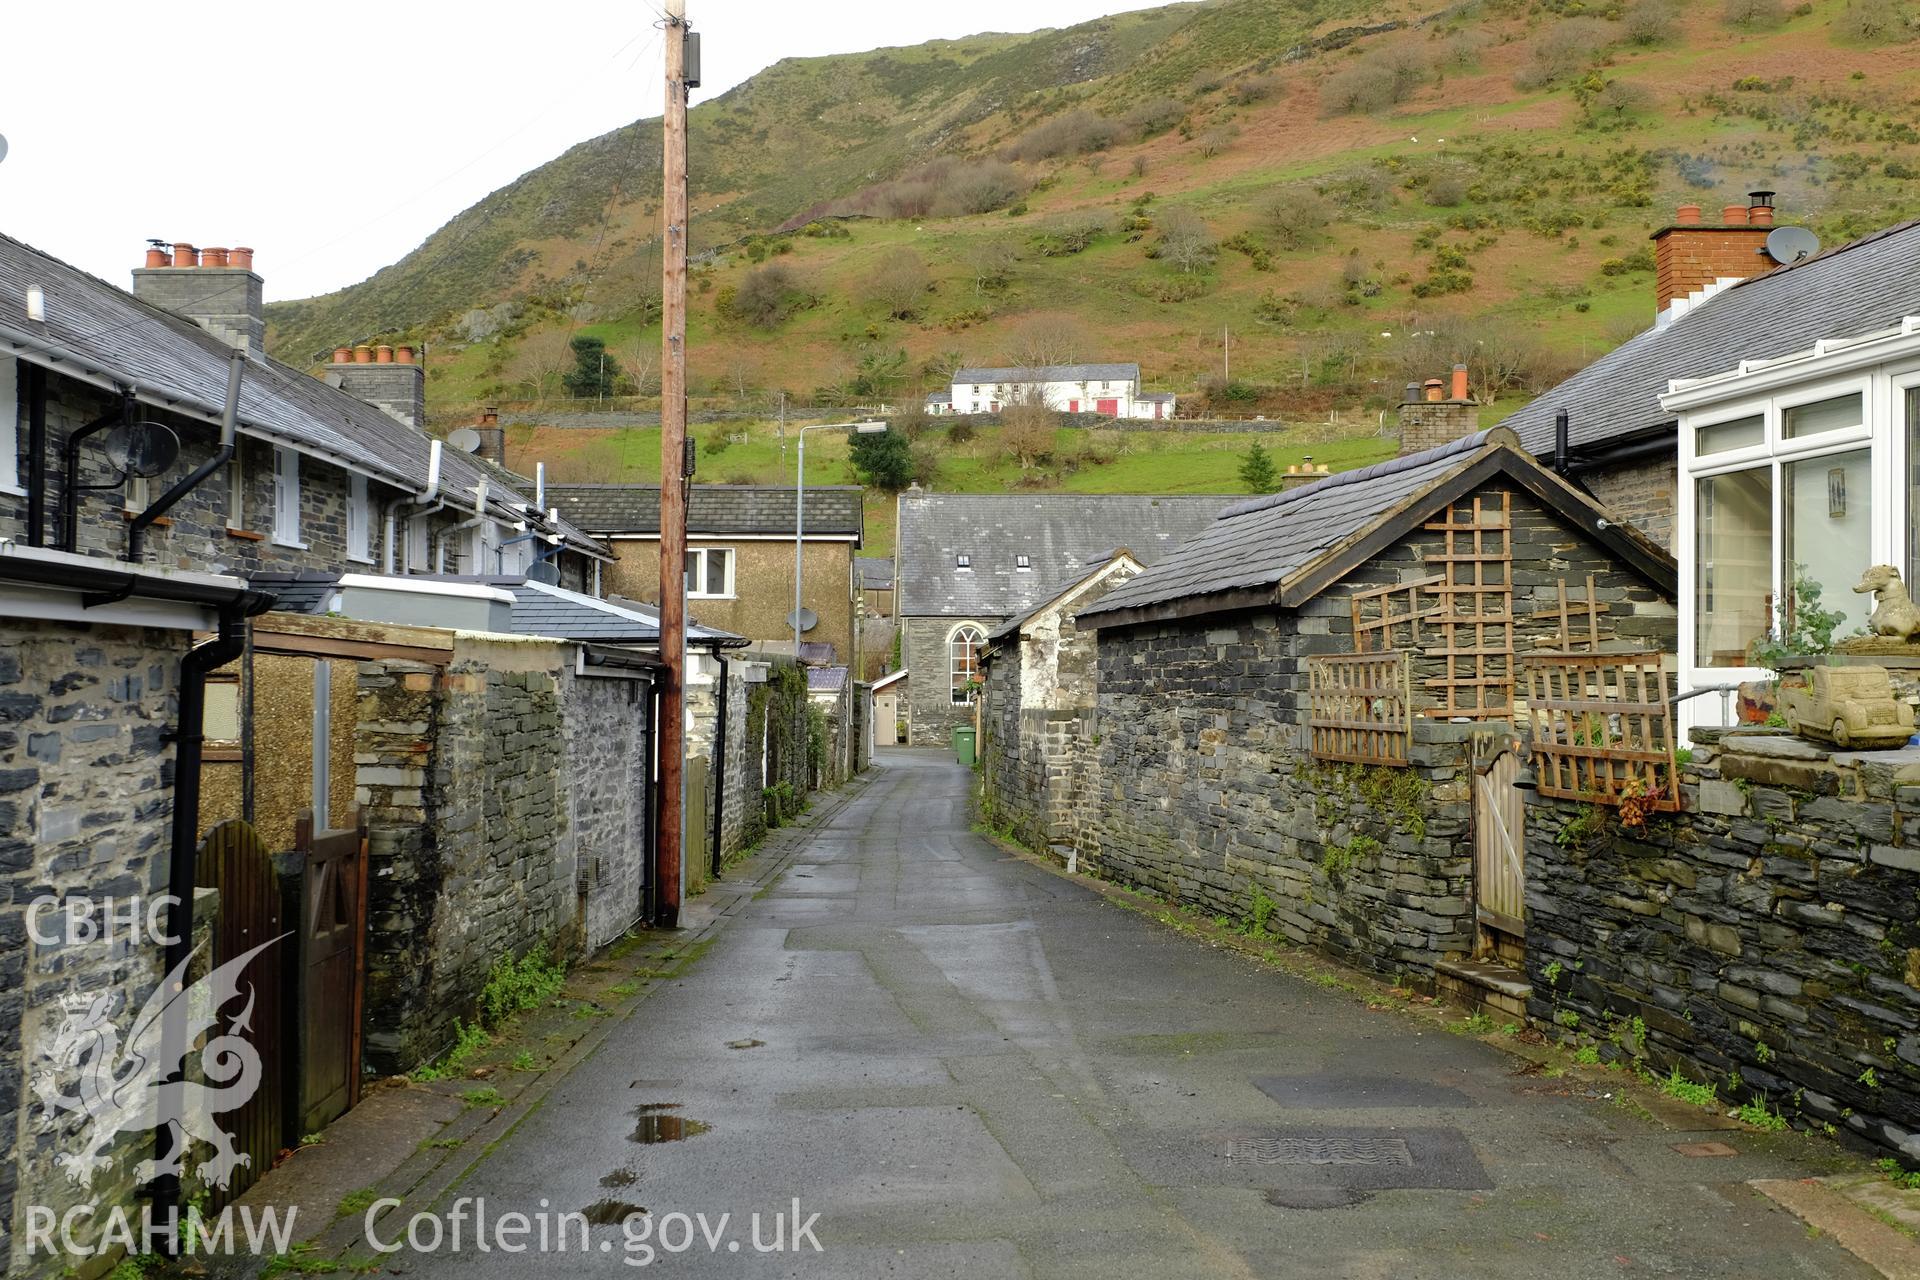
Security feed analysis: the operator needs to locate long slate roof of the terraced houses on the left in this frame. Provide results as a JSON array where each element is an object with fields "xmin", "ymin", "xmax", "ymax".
[{"xmin": 0, "ymin": 236, "xmax": 611, "ymax": 558}]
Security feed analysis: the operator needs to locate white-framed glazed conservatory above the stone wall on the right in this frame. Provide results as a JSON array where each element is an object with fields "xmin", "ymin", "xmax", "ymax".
[{"xmin": 1661, "ymin": 317, "xmax": 1920, "ymax": 725}]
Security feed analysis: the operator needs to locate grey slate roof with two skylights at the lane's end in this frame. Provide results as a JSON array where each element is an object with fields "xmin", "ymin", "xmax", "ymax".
[{"xmin": 895, "ymin": 491, "xmax": 1238, "ymax": 618}]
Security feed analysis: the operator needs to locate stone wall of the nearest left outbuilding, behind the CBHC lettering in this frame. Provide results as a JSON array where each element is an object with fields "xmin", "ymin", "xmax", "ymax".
[{"xmin": 0, "ymin": 620, "xmax": 190, "ymax": 1274}]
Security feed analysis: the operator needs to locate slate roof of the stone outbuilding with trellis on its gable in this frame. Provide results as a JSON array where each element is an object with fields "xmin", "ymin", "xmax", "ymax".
[{"xmin": 1077, "ymin": 428, "xmax": 1674, "ymax": 626}]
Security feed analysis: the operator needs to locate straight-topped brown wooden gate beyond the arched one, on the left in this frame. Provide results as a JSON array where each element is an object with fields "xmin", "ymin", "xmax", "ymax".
[{"xmin": 290, "ymin": 810, "xmax": 367, "ymax": 1134}]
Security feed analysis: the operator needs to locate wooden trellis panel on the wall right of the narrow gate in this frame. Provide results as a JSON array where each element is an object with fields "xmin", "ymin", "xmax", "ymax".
[{"xmin": 1523, "ymin": 652, "xmax": 1680, "ymax": 810}]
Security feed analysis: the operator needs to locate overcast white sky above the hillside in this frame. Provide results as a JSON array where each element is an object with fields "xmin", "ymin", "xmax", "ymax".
[{"xmin": 0, "ymin": 0, "xmax": 1150, "ymax": 297}]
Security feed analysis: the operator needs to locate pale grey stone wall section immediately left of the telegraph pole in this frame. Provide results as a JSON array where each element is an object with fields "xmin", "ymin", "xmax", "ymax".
[{"xmin": 557, "ymin": 672, "xmax": 653, "ymax": 952}]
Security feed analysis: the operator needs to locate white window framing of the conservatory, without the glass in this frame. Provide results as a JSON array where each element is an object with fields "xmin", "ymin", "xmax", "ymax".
[{"xmin": 1674, "ymin": 357, "xmax": 1920, "ymax": 731}]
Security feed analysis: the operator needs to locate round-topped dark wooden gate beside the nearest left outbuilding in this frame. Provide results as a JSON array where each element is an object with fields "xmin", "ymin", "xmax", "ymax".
[{"xmin": 194, "ymin": 818, "xmax": 294, "ymax": 1211}]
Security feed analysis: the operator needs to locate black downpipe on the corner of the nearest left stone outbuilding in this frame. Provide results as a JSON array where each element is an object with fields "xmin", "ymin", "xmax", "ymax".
[{"xmin": 154, "ymin": 597, "xmax": 259, "ymax": 1243}]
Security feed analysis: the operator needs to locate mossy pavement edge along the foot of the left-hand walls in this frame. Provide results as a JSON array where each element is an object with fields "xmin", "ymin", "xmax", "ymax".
[{"xmin": 313, "ymin": 773, "xmax": 872, "ymax": 1257}]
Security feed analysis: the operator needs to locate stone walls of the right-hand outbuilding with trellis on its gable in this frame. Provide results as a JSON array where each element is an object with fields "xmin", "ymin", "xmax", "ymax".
[{"xmin": 1075, "ymin": 486, "xmax": 1674, "ymax": 981}]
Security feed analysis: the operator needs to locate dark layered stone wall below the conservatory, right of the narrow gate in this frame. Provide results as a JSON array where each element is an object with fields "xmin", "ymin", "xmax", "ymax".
[{"xmin": 1526, "ymin": 729, "xmax": 1920, "ymax": 1161}]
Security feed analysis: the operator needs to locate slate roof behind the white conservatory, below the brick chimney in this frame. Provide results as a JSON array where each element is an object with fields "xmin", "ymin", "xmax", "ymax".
[{"xmin": 1505, "ymin": 221, "xmax": 1920, "ymax": 461}]
